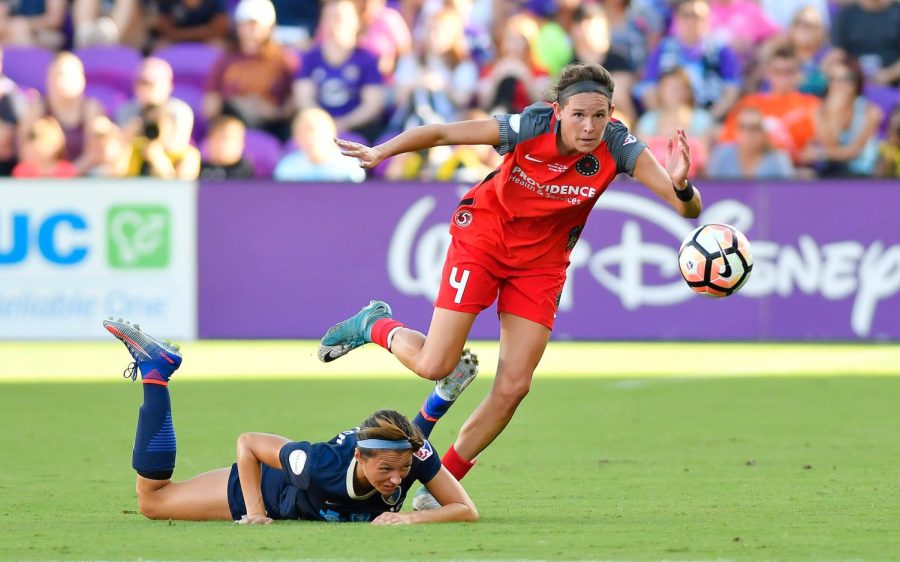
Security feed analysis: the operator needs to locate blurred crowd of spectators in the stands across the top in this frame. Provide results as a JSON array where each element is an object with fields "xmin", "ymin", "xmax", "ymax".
[{"xmin": 0, "ymin": 0, "xmax": 900, "ymax": 182}]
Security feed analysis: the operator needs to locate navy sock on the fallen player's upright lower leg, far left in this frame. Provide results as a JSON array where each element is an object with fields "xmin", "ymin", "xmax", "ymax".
[{"xmin": 131, "ymin": 384, "xmax": 175, "ymax": 480}]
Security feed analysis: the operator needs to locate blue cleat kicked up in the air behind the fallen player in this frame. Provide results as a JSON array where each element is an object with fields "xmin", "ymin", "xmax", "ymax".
[{"xmin": 103, "ymin": 318, "xmax": 182, "ymax": 384}]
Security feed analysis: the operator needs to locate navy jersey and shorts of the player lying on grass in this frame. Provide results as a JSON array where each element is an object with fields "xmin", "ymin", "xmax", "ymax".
[{"xmin": 228, "ymin": 428, "xmax": 441, "ymax": 522}]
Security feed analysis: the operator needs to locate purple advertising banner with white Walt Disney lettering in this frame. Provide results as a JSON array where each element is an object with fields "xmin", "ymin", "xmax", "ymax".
[{"xmin": 198, "ymin": 180, "xmax": 900, "ymax": 341}]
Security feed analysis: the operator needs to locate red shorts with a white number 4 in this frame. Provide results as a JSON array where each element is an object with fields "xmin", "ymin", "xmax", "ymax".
[{"xmin": 434, "ymin": 238, "xmax": 566, "ymax": 330}]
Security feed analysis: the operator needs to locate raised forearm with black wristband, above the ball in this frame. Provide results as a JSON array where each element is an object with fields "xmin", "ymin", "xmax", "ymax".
[{"xmin": 633, "ymin": 129, "xmax": 703, "ymax": 219}]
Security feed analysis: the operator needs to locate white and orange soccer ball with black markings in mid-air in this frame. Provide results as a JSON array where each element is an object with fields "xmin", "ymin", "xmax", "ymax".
[{"xmin": 678, "ymin": 224, "xmax": 753, "ymax": 298}]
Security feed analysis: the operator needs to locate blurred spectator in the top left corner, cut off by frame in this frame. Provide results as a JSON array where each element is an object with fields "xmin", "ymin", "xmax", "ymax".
[{"xmin": 0, "ymin": 0, "xmax": 68, "ymax": 50}]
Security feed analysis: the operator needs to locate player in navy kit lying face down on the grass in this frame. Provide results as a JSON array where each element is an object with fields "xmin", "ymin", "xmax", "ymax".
[{"xmin": 103, "ymin": 320, "xmax": 478, "ymax": 525}]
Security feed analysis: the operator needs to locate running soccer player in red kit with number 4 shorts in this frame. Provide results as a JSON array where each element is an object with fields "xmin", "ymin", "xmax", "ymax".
[{"xmin": 319, "ymin": 64, "xmax": 702, "ymax": 505}]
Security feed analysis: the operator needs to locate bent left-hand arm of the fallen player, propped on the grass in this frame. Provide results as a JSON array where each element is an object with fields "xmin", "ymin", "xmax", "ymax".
[{"xmin": 237, "ymin": 433, "xmax": 291, "ymax": 525}]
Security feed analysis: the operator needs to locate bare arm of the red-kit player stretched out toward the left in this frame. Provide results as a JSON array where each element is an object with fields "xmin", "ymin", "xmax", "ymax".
[{"xmin": 334, "ymin": 119, "xmax": 500, "ymax": 168}]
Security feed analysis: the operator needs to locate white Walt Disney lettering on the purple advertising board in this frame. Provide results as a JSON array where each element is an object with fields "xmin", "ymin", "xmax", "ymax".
[{"xmin": 387, "ymin": 191, "xmax": 900, "ymax": 337}]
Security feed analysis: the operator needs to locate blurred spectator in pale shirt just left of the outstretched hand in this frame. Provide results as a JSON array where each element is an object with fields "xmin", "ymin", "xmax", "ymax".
[{"xmin": 273, "ymin": 107, "xmax": 366, "ymax": 182}]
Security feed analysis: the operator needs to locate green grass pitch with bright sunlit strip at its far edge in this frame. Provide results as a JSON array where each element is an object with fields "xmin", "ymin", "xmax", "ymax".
[{"xmin": 0, "ymin": 341, "xmax": 900, "ymax": 560}]
